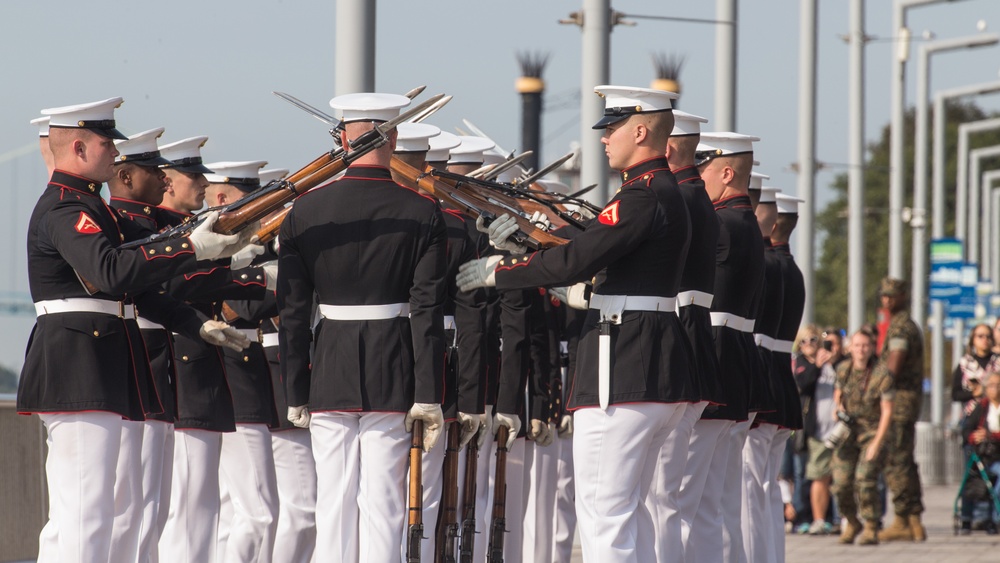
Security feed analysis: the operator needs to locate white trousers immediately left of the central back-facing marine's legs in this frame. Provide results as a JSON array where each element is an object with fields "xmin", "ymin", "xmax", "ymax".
[{"xmin": 271, "ymin": 428, "xmax": 316, "ymax": 563}]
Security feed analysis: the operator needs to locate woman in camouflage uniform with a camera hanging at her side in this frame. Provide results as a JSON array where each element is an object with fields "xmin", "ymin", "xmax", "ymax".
[{"xmin": 833, "ymin": 329, "xmax": 895, "ymax": 545}]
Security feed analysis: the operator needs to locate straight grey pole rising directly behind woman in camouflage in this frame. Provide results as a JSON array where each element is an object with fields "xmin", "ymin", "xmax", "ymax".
[{"xmin": 847, "ymin": 0, "xmax": 866, "ymax": 330}]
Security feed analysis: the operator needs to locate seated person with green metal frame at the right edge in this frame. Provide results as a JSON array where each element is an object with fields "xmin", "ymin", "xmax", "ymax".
[{"xmin": 961, "ymin": 372, "xmax": 1000, "ymax": 536}]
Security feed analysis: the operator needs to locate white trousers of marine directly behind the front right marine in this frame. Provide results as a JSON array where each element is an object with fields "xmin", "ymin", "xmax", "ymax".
[{"xmin": 644, "ymin": 402, "xmax": 708, "ymax": 563}]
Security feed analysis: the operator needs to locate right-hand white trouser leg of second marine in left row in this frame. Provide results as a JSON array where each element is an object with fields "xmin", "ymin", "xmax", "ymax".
[{"xmin": 138, "ymin": 420, "xmax": 174, "ymax": 563}]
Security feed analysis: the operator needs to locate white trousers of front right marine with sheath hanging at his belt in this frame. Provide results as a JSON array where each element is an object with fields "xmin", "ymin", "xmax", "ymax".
[{"xmin": 573, "ymin": 403, "xmax": 684, "ymax": 563}]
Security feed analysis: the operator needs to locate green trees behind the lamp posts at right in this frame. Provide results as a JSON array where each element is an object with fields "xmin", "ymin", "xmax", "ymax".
[{"xmin": 816, "ymin": 102, "xmax": 1000, "ymax": 326}]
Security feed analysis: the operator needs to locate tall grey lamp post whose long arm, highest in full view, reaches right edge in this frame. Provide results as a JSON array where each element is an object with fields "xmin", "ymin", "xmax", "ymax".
[{"xmin": 910, "ymin": 33, "xmax": 1000, "ymax": 325}]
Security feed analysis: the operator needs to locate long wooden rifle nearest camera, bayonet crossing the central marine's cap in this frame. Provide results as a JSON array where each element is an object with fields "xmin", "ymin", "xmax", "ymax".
[{"xmin": 121, "ymin": 94, "xmax": 444, "ymax": 248}]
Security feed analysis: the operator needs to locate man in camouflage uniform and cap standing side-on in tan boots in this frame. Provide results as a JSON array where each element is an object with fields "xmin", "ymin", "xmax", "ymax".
[{"xmin": 879, "ymin": 278, "xmax": 927, "ymax": 541}]
